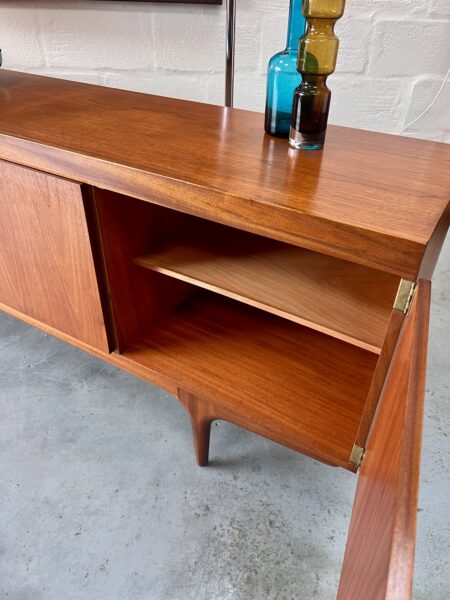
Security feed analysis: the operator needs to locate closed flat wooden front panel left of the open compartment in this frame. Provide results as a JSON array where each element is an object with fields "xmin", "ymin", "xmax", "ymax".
[{"xmin": 0, "ymin": 161, "xmax": 108, "ymax": 351}]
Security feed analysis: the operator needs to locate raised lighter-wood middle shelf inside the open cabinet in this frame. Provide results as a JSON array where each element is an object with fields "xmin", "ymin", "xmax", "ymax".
[{"xmin": 134, "ymin": 220, "xmax": 399, "ymax": 354}]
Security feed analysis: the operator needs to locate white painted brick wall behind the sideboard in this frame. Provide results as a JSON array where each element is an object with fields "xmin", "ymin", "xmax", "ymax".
[{"xmin": 0, "ymin": 0, "xmax": 450, "ymax": 142}]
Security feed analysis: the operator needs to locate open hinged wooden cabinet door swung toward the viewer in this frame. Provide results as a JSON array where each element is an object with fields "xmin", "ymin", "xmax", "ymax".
[{"xmin": 337, "ymin": 281, "xmax": 431, "ymax": 600}]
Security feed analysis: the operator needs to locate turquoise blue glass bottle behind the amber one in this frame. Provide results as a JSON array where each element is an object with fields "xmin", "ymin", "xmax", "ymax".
[{"xmin": 264, "ymin": 0, "xmax": 306, "ymax": 138}]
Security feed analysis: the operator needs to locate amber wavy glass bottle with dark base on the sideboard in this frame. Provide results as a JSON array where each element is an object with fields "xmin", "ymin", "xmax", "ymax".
[{"xmin": 289, "ymin": 0, "xmax": 345, "ymax": 150}]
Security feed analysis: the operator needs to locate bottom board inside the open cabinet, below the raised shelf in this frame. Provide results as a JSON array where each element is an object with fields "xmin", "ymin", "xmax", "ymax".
[{"xmin": 121, "ymin": 291, "xmax": 377, "ymax": 468}]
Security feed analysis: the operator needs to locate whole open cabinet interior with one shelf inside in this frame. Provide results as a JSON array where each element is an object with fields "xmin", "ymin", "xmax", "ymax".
[{"xmin": 94, "ymin": 190, "xmax": 399, "ymax": 468}]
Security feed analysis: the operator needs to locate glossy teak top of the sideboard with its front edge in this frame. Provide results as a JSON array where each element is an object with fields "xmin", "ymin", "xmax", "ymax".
[{"xmin": 0, "ymin": 71, "xmax": 450, "ymax": 280}]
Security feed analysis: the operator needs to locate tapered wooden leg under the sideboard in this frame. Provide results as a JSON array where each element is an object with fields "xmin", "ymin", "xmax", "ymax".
[{"xmin": 178, "ymin": 390, "xmax": 214, "ymax": 467}]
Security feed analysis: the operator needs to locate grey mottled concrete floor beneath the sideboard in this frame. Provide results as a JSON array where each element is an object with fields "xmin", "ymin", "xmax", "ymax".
[{"xmin": 0, "ymin": 238, "xmax": 450, "ymax": 600}]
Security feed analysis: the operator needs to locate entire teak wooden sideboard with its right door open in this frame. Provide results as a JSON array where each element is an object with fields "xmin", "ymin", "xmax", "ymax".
[{"xmin": 0, "ymin": 71, "xmax": 450, "ymax": 600}]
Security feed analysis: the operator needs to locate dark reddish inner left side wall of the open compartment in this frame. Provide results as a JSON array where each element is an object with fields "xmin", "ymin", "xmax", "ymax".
[{"xmin": 92, "ymin": 189, "xmax": 193, "ymax": 351}]
